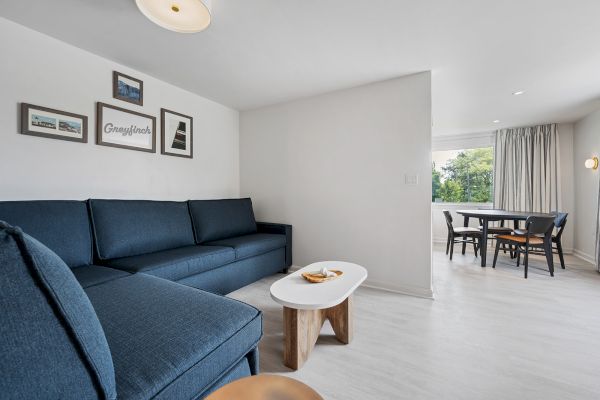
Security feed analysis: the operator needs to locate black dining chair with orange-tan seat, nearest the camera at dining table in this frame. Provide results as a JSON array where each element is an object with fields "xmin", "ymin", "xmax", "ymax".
[{"xmin": 492, "ymin": 216, "xmax": 555, "ymax": 279}]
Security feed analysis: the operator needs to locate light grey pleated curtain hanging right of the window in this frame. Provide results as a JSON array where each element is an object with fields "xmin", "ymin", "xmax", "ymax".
[{"xmin": 494, "ymin": 124, "xmax": 561, "ymax": 212}]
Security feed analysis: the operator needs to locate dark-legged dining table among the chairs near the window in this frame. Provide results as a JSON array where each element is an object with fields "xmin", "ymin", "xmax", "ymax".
[{"xmin": 456, "ymin": 209, "xmax": 556, "ymax": 267}]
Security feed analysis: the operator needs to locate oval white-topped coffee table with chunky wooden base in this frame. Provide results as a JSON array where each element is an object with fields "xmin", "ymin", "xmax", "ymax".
[{"xmin": 271, "ymin": 261, "xmax": 367, "ymax": 369}]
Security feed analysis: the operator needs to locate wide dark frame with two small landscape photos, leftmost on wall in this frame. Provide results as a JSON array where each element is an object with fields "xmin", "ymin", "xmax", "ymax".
[{"xmin": 20, "ymin": 103, "xmax": 88, "ymax": 143}]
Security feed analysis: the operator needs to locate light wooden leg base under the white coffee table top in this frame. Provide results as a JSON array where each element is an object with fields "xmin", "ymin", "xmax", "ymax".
[{"xmin": 283, "ymin": 295, "xmax": 354, "ymax": 370}]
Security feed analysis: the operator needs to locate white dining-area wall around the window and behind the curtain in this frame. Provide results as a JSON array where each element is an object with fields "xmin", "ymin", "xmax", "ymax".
[{"xmin": 431, "ymin": 124, "xmax": 575, "ymax": 253}]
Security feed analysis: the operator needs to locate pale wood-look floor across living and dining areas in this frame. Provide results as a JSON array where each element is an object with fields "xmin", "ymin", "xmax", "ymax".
[{"xmin": 231, "ymin": 246, "xmax": 600, "ymax": 400}]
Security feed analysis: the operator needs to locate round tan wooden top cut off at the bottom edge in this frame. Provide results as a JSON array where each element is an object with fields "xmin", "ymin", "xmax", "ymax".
[{"xmin": 206, "ymin": 374, "xmax": 323, "ymax": 400}]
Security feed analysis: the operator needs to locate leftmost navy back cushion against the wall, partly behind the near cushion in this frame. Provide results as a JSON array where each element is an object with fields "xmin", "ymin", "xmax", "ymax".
[{"xmin": 0, "ymin": 200, "xmax": 92, "ymax": 268}]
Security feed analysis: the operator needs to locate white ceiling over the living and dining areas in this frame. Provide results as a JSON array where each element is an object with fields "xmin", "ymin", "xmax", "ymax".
[{"xmin": 0, "ymin": 0, "xmax": 600, "ymax": 135}]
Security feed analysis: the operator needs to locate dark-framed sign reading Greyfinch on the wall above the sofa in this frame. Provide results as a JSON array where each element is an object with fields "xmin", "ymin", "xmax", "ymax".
[{"xmin": 96, "ymin": 102, "xmax": 156, "ymax": 153}]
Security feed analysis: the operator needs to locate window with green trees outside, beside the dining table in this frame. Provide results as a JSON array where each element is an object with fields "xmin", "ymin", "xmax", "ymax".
[{"xmin": 431, "ymin": 147, "xmax": 494, "ymax": 203}]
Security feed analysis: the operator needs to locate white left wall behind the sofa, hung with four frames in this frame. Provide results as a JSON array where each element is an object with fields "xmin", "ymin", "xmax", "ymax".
[{"xmin": 0, "ymin": 18, "xmax": 239, "ymax": 200}]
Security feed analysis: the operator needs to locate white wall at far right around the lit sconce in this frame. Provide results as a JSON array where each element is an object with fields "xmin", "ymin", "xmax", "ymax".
[{"xmin": 571, "ymin": 110, "xmax": 600, "ymax": 262}]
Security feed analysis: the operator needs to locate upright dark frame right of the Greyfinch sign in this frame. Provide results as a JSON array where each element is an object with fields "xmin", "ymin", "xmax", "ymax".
[{"xmin": 160, "ymin": 108, "xmax": 194, "ymax": 158}]
